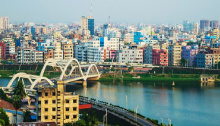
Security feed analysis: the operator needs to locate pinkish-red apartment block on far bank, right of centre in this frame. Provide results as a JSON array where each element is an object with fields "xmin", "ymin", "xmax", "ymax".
[{"xmin": 152, "ymin": 49, "xmax": 168, "ymax": 66}]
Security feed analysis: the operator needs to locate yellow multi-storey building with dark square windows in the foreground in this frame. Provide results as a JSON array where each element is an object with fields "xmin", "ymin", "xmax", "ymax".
[{"xmin": 37, "ymin": 81, "xmax": 79, "ymax": 126}]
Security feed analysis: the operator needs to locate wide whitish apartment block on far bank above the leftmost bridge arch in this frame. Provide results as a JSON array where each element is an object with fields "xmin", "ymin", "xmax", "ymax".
[{"xmin": 16, "ymin": 48, "xmax": 44, "ymax": 64}]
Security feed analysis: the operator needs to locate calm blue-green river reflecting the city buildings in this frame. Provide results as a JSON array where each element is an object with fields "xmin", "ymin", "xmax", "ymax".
[{"xmin": 0, "ymin": 78, "xmax": 220, "ymax": 126}]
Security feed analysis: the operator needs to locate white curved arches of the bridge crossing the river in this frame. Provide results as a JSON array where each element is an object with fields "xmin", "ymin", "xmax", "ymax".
[{"xmin": 7, "ymin": 58, "xmax": 100, "ymax": 89}]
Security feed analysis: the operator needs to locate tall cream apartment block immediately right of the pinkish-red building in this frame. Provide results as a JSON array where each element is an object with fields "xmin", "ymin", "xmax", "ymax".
[{"xmin": 168, "ymin": 43, "xmax": 182, "ymax": 66}]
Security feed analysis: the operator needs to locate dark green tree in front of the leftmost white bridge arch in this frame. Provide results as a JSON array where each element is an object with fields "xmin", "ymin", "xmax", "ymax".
[{"xmin": 12, "ymin": 81, "xmax": 27, "ymax": 99}]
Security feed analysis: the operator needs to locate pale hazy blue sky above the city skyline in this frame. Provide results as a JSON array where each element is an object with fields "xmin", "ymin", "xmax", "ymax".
[{"xmin": 0, "ymin": 0, "xmax": 220, "ymax": 24}]
